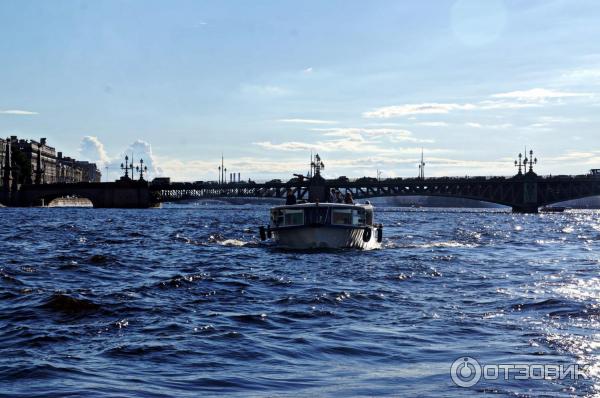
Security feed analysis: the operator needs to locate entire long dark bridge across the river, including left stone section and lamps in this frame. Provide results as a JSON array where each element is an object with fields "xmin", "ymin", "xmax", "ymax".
[{"xmin": 0, "ymin": 149, "xmax": 600, "ymax": 213}]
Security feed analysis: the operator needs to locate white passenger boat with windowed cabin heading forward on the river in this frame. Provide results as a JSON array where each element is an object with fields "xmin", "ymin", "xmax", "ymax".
[{"xmin": 260, "ymin": 202, "xmax": 383, "ymax": 250}]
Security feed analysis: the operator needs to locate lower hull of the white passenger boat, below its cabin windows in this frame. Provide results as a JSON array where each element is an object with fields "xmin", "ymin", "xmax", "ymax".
[{"xmin": 271, "ymin": 225, "xmax": 381, "ymax": 250}]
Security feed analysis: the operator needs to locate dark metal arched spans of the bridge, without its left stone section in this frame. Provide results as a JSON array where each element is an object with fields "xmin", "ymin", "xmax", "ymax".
[{"xmin": 150, "ymin": 174, "xmax": 600, "ymax": 213}]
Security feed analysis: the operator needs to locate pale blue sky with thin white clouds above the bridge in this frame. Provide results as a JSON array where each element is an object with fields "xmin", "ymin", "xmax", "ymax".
[{"xmin": 0, "ymin": 0, "xmax": 600, "ymax": 181}]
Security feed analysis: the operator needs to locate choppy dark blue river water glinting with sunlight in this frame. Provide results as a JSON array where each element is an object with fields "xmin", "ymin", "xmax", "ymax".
[{"xmin": 0, "ymin": 204, "xmax": 600, "ymax": 397}]
